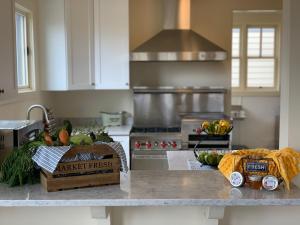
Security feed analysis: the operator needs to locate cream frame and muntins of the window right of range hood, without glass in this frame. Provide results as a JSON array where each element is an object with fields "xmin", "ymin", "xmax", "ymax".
[{"xmin": 232, "ymin": 23, "xmax": 281, "ymax": 96}]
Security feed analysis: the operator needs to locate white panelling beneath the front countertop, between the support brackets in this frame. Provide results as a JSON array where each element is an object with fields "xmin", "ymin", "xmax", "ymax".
[{"xmin": 0, "ymin": 206, "xmax": 300, "ymax": 225}]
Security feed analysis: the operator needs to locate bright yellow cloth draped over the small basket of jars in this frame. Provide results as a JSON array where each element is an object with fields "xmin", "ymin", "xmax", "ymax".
[{"xmin": 218, "ymin": 148, "xmax": 300, "ymax": 190}]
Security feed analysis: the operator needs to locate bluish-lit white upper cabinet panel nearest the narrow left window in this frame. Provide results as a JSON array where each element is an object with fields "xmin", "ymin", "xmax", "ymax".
[{"xmin": 38, "ymin": 0, "xmax": 69, "ymax": 91}]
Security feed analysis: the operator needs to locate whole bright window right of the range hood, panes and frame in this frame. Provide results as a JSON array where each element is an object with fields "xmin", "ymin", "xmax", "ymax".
[{"xmin": 231, "ymin": 24, "xmax": 279, "ymax": 93}]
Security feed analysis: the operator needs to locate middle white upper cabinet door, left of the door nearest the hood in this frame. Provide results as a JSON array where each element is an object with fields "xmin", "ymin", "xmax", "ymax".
[{"xmin": 65, "ymin": 0, "xmax": 95, "ymax": 90}]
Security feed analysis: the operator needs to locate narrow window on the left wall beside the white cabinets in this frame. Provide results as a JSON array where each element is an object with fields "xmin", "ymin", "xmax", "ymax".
[{"xmin": 15, "ymin": 4, "xmax": 34, "ymax": 92}]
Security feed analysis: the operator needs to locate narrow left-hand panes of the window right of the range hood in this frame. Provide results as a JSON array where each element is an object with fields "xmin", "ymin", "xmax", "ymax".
[{"xmin": 231, "ymin": 28, "xmax": 241, "ymax": 87}]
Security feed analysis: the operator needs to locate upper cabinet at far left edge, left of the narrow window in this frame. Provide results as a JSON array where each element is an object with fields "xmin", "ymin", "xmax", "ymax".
[{"xmin": 0, "ymin": 0, "xmax": 17, "ymax": 101}]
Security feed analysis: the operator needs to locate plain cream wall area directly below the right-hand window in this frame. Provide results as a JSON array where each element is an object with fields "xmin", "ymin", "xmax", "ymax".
[{"xmin": 232, "ymin": 96, "xmax": 280, "ymax": 149}]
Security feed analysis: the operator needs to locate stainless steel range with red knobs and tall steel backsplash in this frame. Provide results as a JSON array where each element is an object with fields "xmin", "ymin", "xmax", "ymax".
[{"xmin": 130, "ymin": 87, "xmax": 226, "ymax": 170}]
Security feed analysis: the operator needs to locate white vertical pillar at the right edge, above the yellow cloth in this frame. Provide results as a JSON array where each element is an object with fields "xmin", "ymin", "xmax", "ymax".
[{"xmin": 280, "ymin": 0, "xmax": 300, "ymax": 150}]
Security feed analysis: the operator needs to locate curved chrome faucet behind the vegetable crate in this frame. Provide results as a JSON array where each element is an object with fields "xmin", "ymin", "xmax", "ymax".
[{"xmin": 27, "ymin": 105, "xmax": 56, "ymax": 134}]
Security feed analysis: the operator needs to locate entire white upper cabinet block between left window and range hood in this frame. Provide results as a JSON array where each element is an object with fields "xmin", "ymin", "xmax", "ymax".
[{"xmin": 39, "ymin": 0, "xmax": 129, "ymax": 91}]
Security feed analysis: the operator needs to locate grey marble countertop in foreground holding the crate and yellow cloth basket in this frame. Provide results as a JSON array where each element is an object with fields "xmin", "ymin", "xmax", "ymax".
[{"xmin": 0, "ymin": 171, "xmax": 300, "ymax": 207}]
